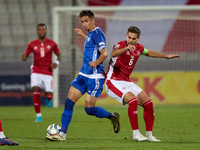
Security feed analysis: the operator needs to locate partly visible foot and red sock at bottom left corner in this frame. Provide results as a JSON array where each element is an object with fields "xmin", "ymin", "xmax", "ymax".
[{"xmin": 0, "ymin": 120, "xmax": 19, "ymax": 146}]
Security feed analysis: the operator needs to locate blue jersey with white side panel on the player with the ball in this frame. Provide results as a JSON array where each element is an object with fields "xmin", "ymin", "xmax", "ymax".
[{"xmin": 80, "ymin": 27, "xmax": 106, "ymax": 75}]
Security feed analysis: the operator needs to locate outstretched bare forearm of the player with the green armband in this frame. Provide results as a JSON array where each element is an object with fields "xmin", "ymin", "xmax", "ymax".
[{"xmin": 145, "ymin": 50, "xmax": 180, "ymax": 59}]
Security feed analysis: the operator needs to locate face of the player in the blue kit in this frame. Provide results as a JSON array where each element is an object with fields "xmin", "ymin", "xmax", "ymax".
[{"xmin": 81, "ymin": 16, "xmax": 95, "ymax": 32}]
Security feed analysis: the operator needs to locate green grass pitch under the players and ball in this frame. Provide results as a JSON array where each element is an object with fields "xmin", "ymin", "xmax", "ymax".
[{"xmin": 0, "ymin": 105, "xmax": 200, "ymax": 150}]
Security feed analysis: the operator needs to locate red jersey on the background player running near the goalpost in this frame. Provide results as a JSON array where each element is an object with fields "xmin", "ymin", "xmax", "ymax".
[{"xmin": 26, "ymin": 38, "xmax": 60, "ymax": 75}]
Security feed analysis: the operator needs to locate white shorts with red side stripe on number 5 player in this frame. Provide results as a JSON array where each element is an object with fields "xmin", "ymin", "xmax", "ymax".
[{"xmin": 105, "ymin": 79, "xmax": 142, "ymax": 105}]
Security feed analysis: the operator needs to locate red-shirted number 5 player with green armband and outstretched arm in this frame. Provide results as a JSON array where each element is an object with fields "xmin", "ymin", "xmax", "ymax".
[{"xmin": 105, "ymin": 26, "xmax": 180, "ymax": 142}]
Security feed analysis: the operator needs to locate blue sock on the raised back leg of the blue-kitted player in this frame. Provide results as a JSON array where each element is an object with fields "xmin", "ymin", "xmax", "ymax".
[{"xmin": 85, "ymin": 107, "xmax": 113, "ymax": 119}]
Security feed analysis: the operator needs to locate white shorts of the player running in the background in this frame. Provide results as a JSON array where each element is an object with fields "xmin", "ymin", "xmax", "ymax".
[{"xmin": 31, "ymin": 73, "xmax": 53, "ymax": 92}]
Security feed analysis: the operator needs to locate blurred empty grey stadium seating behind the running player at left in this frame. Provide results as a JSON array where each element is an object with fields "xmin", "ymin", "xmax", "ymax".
[{"xmin": 0, "ymin": 0, "xmax": 72, "ymax": 62}]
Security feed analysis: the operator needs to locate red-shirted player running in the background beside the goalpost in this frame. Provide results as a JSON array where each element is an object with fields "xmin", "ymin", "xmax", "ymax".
[{"xmin": 22, "ymin": 23, "xmax": 61, "ymax": 122}]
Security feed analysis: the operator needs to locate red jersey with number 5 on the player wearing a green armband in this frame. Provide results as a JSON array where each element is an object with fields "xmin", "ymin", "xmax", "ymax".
[{"xmin": 106, "ymin": 41, "xmax": 144, "ymax": 81}]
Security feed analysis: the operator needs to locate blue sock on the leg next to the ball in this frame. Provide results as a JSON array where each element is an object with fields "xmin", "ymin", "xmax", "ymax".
[{"xmin": 61, "ymin": 98, "xmax": 75, "ymax": 134}]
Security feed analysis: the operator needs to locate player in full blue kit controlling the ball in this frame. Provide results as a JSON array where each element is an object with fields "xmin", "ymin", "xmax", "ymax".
[{"xmin": 46, "ymin": 10, "xmax": 120, "ymax": 141}]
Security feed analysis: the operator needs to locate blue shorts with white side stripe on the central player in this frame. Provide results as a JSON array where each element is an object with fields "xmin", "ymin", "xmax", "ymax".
[{"xmin": 71, "ymin": 75, "xmax": 105, "ymax": 97}]
